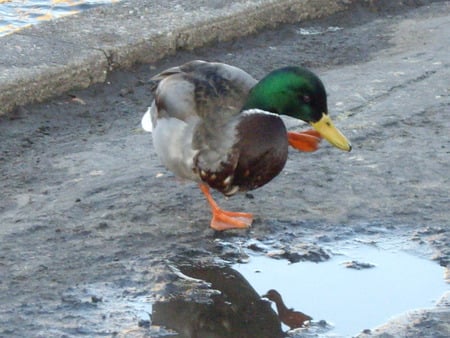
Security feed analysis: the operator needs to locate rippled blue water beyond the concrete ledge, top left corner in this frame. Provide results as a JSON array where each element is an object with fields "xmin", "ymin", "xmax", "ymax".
[{"xmin": 0, "ymin": 0, "xmax": 119, "ymax": 37}]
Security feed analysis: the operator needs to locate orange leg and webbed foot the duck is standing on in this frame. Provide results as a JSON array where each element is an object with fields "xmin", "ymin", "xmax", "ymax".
[{"xmin": 199, "ymin": 183, "xmax": 253, "ymax": 231}]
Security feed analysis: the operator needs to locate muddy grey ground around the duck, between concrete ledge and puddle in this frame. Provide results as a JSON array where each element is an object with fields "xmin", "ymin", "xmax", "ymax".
[{"xmin": 0, "ymin": 1, "xmax": 450, "ymax": 337}]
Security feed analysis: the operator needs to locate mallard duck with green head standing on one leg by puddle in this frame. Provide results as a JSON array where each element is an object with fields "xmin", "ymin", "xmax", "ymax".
[{"xmin": 142, "ymin": 60, "xmax": 351, "ymax": 231}]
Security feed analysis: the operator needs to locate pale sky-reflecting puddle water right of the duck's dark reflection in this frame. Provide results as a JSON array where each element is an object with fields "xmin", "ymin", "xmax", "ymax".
[{"xmin": 233, "ymin": 246, "xmax": 449, "ymax": 336}]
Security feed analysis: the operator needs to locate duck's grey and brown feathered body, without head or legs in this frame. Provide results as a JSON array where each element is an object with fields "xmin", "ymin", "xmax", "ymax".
[{"xmin": 150, "ymin": 61, "xmax": 288, "ymax": 195}]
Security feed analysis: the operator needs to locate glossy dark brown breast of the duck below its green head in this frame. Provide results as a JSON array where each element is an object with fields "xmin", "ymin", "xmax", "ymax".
[{"xmin": 194, "ymin": 110, "xmax": 288, "ymax": 196}]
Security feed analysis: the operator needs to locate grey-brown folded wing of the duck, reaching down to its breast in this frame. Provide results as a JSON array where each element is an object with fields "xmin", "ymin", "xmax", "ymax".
[{"xmin": 151, "ymin": 60, "xmax": 257, "ymax": 168}]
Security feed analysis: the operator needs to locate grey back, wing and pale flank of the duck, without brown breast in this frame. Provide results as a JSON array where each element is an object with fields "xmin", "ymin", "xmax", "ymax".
[{"xmin": 146, "ymin": 61, "xmax": 256, "ymax": 179}]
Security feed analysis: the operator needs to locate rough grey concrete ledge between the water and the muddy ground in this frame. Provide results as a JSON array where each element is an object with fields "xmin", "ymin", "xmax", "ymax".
[{"xmin": 0, "ymin": 0, "xmax": 353, "ymax": 115}]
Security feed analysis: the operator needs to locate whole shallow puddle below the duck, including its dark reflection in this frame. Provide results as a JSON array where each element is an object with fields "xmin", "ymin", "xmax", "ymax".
[{"xmin": 63, "ymin": 246, "xmax": 448, "ymax": 338}]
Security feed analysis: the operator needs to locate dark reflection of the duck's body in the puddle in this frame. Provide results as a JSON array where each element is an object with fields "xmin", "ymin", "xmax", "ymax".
[{"xmin": 152, "ymin": 266, "xmax": 284, "ymax": 338}]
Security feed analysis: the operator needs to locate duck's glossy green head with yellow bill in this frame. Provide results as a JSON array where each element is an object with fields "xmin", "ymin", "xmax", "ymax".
[{"xmin": 244, "ymin": 67, "xmax": 352, "ymax": 151}]
